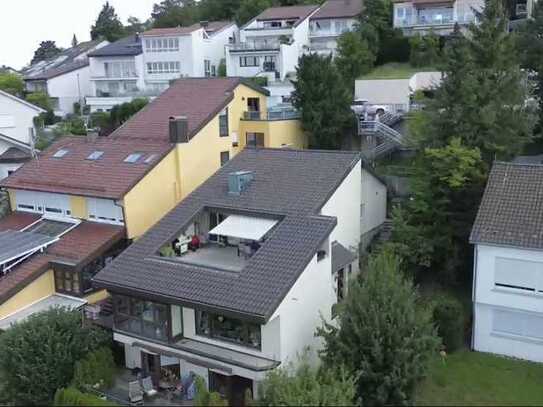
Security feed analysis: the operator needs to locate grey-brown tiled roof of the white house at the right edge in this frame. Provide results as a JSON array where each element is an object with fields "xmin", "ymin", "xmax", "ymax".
[{"xmin": 470, "ymin": 162, "xmax": 543, "ymax": 249}]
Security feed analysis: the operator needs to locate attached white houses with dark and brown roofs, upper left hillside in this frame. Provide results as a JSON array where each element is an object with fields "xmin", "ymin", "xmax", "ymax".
[{"xmin": 86, "ymin": 21, "xmax": 237, "ymax": 112}]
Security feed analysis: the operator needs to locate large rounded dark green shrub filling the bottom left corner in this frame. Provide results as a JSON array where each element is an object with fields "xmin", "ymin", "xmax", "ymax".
[{"xmin": 0, "ymin": 308, "xmax": 111, "ymax": 405}]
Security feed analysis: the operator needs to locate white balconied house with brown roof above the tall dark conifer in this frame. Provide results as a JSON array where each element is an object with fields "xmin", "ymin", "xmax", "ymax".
[{"xmin": 309, "ymin": 0, "xmax": 362, "ymax": 55}]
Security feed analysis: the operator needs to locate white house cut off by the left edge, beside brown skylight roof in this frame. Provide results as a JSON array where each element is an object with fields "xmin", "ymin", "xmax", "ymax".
[{"xmin": 0, "ymin": 90, "xmax": 45, "ymax": 179}]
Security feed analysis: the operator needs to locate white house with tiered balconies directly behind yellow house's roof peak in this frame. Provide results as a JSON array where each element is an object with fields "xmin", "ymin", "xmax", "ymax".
[{"xmin": 226, "ymin": 5, "xmax": 319, "ymax": 82}]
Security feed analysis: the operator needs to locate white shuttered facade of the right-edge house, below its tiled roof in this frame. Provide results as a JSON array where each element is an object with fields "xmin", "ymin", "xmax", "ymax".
[{"xmin": 472, "ymin": 244, "xmax": 543, "ymax": 362}]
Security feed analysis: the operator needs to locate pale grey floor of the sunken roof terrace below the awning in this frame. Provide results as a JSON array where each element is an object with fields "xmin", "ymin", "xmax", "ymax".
[{"xmin": 173, "ymin": 244, "xmax": 247, "ymax": 272}]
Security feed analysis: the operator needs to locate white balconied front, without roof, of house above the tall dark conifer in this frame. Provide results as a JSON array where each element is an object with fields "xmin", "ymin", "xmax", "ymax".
[{"xmin": 309, "ymin": 18, "xmax": 358, "ymax": 55}]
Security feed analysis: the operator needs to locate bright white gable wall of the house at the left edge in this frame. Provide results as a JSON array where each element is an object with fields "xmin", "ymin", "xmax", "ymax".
[{"xmin": 0, "ymin": 93, "xmax": 40, "ymax": 146}]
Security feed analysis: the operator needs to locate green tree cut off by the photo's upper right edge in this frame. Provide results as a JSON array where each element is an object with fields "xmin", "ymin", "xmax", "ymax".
[{"xmin": 519, "ymin": 2, "xmax": 543, "ymax": 134}]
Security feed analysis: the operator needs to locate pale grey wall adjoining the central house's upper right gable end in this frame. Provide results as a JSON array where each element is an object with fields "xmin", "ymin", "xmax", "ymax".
[{"xmin": 360, "ymin": 169, "xmax": 387, "ymax": 235}]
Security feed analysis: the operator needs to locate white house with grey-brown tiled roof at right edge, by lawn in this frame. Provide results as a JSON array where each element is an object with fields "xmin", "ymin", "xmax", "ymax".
[{"xmin": 470, "ymin": 162, "xmax": 543, "ymax": 362}]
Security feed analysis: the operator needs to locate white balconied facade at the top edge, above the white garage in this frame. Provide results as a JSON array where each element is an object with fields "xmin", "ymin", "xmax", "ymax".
[{"xmin": 393, "ymin": 0, "xmax": 484, "ymax": 35}]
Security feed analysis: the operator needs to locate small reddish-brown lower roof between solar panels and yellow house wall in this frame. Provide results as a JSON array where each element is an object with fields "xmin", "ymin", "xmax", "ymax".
[{"xmin": 47, "ymin": 222, "xmax": 126, "ymax": 262}]
